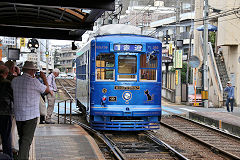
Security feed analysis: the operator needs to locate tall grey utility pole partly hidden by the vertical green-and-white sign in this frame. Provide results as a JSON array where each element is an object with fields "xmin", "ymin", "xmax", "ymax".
[{"xmin": 175, "ymin": 0, "xmax": 181, "ymax": 104}]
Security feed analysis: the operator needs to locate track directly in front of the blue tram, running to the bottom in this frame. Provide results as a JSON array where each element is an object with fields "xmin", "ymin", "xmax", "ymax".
[{"xmin": 57, "ymin": 114, "xmax": 187, "ymax": 160}]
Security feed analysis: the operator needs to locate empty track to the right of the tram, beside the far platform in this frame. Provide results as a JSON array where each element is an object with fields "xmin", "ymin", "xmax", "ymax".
[{"xmin": 161, "ymin": 116, "xmax": 240, "ymax": 159}]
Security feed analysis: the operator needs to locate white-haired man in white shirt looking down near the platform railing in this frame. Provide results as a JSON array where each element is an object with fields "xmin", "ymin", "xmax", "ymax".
[{"xmin": 45, "ymin": 68, "xmax": 60, "ymax": 124}]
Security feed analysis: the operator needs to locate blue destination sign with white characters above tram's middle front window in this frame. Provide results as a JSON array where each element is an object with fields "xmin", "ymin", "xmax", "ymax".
[{"xmin": 113, "ymin": 44, "xmax": 143, "ymax": 52}]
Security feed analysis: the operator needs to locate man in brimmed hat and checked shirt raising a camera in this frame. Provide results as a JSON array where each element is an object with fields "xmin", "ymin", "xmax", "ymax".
[{"xmin": 12, "ymin": 61, "xmax": 50, "ymax": 159}]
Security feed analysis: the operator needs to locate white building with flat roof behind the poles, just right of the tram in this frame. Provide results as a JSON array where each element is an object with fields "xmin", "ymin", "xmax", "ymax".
[{"xmin": 150, "ymin": 12, "xmax": 194, "ymax": 90}]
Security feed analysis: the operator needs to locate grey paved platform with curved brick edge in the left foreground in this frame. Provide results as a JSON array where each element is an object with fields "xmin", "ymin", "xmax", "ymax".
[{"xmin": 29, "ymin": 124, "xmax": 104, "ymax": 160}]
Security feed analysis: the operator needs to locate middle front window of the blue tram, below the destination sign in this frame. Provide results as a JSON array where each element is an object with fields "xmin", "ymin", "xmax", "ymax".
[{"xmin": 118, "ymin": 55, "xmax": 137, "ymax": 81}]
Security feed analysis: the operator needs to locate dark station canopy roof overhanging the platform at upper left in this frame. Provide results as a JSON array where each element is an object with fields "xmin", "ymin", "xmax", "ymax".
[{"xmin": 0, "ymin": 0, "xmax": 115, "ymax": 40}]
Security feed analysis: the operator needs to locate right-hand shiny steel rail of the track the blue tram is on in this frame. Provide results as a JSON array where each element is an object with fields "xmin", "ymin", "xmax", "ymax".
[{"xmin": 144, "ymin": 131, "xmax": 188, "ymax": 160}]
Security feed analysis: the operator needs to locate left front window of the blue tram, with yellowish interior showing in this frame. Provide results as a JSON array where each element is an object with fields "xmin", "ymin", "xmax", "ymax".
[{"xmin": 96, "ymin": 53, "xmax": 115, "ymax": 80}]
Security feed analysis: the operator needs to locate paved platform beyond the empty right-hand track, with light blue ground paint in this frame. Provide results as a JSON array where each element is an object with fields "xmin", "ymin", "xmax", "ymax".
[{"xmin": 162, "ymin": 99, "xmax": 240, "ymax": 136}]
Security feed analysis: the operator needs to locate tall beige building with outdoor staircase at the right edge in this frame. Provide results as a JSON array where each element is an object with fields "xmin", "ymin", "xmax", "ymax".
[{"xmin": 194, "ymin": 0, "xmax": 240, "ymax": 106}]
